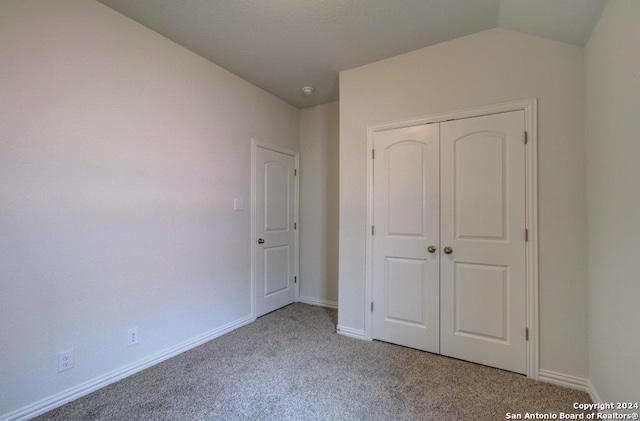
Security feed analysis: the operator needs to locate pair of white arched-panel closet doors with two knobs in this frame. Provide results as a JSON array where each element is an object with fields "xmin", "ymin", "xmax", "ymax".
[{"xmin": 372, "ymin": 111, "xmax": 526, "ymax": 373}]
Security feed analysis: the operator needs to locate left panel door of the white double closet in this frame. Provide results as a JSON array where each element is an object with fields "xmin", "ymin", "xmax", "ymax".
[{"xmin": 372, "ymin": 124, "xmax": 440, "ymax": 352}]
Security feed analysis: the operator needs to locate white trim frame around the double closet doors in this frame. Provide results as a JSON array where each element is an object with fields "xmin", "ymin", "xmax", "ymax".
[{"xmin": 363, "ymin": 98, "xmax": 539, "ymax": 380}]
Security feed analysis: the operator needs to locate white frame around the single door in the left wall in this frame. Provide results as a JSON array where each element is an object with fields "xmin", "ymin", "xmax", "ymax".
[{"xmin": 250, "ymin": 139, "xmax": 300, "ymax": 320}]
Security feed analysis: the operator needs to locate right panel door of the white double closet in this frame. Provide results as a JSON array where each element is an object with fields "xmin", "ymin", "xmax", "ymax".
[{"xmin": 440, "ymin": 111, "xmax": 526, "ymax": 373}]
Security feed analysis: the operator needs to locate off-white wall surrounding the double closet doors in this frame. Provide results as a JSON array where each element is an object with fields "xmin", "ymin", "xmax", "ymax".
[{"xmin": 339, "ymin": 29, "xmax": 588, "ymax": 378}]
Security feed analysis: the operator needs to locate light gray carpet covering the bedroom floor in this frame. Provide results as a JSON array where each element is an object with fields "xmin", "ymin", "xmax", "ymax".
[{"xmin": 37, "ymin": 303, "xmax": 590, "ymax": 421}]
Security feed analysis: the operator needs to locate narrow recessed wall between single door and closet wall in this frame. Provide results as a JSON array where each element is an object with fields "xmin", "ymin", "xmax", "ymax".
[{"xmin": 300, "ymin": 102, "xmax": 340, "ymax": 307}]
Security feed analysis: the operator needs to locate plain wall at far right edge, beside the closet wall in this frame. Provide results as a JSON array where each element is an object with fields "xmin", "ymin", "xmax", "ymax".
[{"xmin": 585, "ymin": 0, "xmax": 640, "ymax": 400}]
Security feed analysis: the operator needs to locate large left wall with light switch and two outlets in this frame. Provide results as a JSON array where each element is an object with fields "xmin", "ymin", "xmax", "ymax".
[{"xmin": 0, "ymin": 0, "xmax": 299, "ymax": 417}]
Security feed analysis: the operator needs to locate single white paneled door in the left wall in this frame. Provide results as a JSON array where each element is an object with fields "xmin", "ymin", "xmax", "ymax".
[{"xmin": 254, "ymin": 146, "xmax": 296, "ymax": 317}]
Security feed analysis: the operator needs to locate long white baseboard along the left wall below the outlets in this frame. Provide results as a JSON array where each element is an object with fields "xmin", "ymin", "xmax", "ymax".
[{"xmin": 0, "ymin": 315, "xmax": 255, "ymax": 421}]
